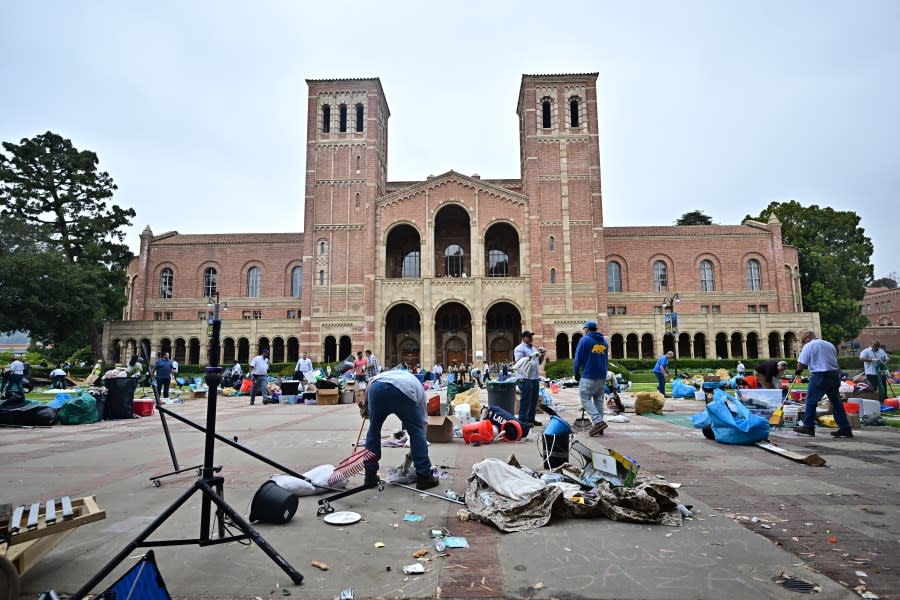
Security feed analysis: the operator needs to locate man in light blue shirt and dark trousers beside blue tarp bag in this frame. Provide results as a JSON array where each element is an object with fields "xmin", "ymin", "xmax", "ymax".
[{"xmin": 794, "ymin": 330, "xmax": 853, "ymax": 437}]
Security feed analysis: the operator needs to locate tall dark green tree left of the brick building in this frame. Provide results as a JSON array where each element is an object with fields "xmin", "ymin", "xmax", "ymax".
[{"xmin": 0, "ymin": 132, "xmax": 135, "ymax": 356}]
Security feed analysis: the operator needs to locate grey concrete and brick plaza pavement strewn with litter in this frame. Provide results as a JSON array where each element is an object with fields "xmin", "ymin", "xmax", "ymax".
[{"xmin": 0, "ymin": 389, "xmax": 900, "ymax": 599}]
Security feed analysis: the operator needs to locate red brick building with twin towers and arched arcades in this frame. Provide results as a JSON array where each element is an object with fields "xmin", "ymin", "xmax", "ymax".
[{"xmin": 104, "ymin": 73, "xmax": 819, "ymax": 365}]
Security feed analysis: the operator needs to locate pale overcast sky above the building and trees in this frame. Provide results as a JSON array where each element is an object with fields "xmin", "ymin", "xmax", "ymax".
[{"xmin": 0, "ymin": 0, "xmax": 900, "ymax": 277}]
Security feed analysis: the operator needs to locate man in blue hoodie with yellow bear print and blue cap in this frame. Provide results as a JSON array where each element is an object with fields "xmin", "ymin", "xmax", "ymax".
[{"xmin": 573, "ymin": 321, "xmax": 609, "ymax": 437}]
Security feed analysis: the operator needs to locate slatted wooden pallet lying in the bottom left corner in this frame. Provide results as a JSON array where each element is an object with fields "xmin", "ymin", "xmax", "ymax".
[{"xmin": 0, "ymin": 496, "xmax": 106, "ymax": 576}]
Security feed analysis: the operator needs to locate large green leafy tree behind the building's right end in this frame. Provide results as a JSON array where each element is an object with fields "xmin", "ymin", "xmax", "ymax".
[{"xmin": 746, "ymin": 200, "xmax": 874, "ymax": 343}]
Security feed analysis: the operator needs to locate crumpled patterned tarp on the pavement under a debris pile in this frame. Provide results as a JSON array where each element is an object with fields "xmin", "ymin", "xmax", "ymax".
[{"xmin": 465, "ymin": 461, "xmax": 682, "ymax": 532}]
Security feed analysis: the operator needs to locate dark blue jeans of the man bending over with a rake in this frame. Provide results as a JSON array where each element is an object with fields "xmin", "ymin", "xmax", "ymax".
[{"xmin": 365, "ymin": 381, "xmax": 431, "ymax": 477}]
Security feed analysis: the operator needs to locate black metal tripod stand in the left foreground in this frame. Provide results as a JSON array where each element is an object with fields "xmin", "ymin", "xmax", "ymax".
[{"xmin": 71, "ymin": 308, "xmax": 303, "ymax": 600}]
